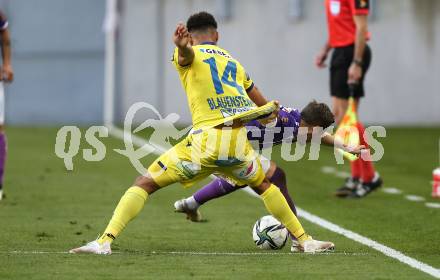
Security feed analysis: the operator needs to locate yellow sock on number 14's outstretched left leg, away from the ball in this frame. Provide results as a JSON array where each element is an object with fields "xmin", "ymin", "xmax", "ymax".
[{"xmin": 98, "ymin": 186, "xmax": 148, "ymax": 243}]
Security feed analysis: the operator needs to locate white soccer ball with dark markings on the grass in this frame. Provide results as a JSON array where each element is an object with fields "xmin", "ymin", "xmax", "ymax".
[{"xmin": 252, "ymin": 216, "xmax": 289, "ymax": 250}]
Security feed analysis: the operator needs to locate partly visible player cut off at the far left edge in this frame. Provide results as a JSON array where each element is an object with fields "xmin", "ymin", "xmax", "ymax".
[{"xmin": 0, "ymin": 11, "xmax": 14, "ymax": 200}]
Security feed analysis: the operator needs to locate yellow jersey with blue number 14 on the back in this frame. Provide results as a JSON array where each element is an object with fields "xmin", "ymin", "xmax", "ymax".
[{"xmin": 173, "ymin": 43, "xmax": 257, "ymax": 129}]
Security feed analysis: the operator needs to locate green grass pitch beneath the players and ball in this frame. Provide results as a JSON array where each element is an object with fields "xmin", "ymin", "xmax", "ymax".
[{"xmin": 0, "ymin": 128, "xmax": 440, "ymax": 280}]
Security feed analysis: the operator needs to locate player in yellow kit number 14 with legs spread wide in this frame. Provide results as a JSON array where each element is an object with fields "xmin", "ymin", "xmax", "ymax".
[{"xmin": 70, "ymin": 12, "xmax": 334, "ymax": 254}]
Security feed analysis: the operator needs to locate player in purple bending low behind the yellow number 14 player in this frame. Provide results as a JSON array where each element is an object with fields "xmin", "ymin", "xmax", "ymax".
[{"xmin": 174, "ymin": 101, "xmax": 363, "ymax": 252}]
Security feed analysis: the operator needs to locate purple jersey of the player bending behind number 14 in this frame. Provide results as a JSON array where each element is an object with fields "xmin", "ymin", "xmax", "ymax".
[{"xmin": 246, "ymin": 106, "xmax": 301, "ymax": 149}]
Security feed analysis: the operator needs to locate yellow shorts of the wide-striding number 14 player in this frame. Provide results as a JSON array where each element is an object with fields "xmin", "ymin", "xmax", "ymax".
[{"xmin": 148, "ymin": 127, "xmax": 265, "ymax": 187}]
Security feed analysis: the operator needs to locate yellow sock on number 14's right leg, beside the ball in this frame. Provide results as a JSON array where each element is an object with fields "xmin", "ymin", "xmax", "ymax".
[{"xmin": 261, "ymin": 184, "xmax": 310, "ymax": 241}]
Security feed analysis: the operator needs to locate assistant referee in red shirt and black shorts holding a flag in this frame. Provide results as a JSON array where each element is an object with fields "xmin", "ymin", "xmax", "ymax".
[{"xmin": 315, "ymin": 0, "xmax": 382, "ymax": 198}]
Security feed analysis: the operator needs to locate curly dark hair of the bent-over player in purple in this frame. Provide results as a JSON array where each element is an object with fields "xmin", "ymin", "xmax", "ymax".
[{"xmin": 301, "ymin": 100, "xmax": 335, "ymax": 129}]
